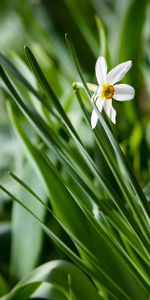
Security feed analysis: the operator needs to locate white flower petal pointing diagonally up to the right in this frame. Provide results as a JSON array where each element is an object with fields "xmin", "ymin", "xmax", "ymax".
[{"xmin": 107, "ymin": 60, "xmax": 132, "ymax": 84}]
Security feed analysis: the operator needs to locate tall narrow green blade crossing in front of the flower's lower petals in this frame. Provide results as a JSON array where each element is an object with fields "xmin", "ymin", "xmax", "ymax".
[{"xmin": 66, "ymin": 35, "xmax": 149, "ymax": 247}]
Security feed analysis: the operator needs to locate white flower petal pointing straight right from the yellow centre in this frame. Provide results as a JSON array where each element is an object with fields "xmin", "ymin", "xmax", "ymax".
[{"xmin": 113, "ymin": 84, "xmax": 135, "ymax": 101}]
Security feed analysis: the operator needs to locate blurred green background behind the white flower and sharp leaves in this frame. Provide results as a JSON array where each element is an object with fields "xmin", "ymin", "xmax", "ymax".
[{"xmin": 0, "ymin": 0, "xmax": 150, "ymax": 295}]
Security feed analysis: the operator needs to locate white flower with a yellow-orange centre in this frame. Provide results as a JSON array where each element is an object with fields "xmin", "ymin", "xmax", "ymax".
[{"xmin": 91, "ymin": 56, "xmax": 135, "ymax": 128}]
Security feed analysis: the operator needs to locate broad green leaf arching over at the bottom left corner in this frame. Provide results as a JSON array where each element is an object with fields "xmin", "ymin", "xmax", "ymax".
[{"xmin": 2, "ymin": 260, "xmax": 102, "ymax": 300}]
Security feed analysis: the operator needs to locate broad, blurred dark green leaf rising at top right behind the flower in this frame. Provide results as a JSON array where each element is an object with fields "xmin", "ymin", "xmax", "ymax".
[{"xmin": 120, "ymin": 0, "xmax": 149, "ymax": 119}]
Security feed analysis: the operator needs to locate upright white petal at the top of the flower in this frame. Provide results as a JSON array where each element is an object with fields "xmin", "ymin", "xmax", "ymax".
[{"xmin": 95, "ymin": 56, "xmax": 107, "ymax": 85}]
